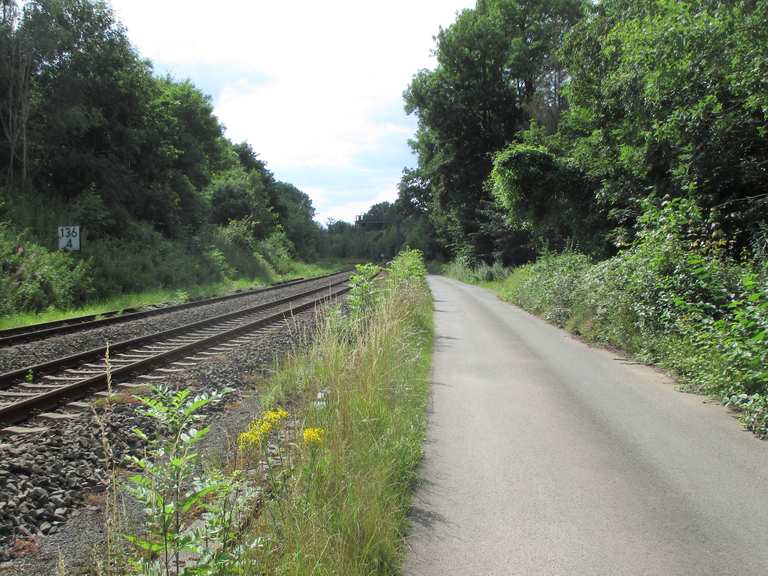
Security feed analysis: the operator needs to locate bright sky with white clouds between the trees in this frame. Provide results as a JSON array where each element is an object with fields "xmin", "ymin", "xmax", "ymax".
[{"xmin": 105, "ymin": 0, "xmax": 475, "ymax": 223}]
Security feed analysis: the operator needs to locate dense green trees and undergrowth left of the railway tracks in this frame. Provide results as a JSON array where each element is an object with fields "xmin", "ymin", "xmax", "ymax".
[{"xmin": 0, "ymin": 0, "xmax": 327, "ymax": 314}]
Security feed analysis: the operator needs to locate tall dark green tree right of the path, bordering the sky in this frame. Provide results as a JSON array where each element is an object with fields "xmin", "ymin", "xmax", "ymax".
[{"xmin": 401, "ymin": 0, "xmax": 582, "ymax": 259}]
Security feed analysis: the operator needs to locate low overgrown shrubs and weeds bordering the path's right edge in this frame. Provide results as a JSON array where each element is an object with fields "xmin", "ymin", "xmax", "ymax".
[{"xmin": 446, "ymin": 200, "xmax": 768, "ymax": 436}]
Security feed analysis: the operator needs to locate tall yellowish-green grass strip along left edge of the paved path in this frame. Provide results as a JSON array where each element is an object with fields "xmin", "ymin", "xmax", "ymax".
[{"xmin": 243, "ymin": 250, "xmax": 432, "ymax": 576}]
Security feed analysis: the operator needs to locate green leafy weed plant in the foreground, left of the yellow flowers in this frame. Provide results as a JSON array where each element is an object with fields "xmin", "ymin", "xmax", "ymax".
[{"xmin": 124, "ymin": 387, "xmax": 248, "ymax": 576}]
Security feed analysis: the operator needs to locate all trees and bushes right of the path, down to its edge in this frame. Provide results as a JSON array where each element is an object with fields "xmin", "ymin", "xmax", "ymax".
[{"xmin": 414, "ymin": 0, "xmax": 768, "ymax": 434}]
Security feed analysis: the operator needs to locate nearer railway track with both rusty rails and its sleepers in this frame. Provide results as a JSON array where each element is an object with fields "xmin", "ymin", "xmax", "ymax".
[{"xmin": 0, "ymin": 273, "xmax": 350, "ymax": 433}]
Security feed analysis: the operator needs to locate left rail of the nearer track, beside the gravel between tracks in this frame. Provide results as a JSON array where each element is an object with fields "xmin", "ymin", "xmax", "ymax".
[{"xmin": 0, "ymin": 275, "xmax": 349, "ymax": 390}]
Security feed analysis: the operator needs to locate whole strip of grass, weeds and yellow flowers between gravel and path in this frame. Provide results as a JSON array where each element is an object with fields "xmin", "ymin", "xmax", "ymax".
[{"xmin": 89, "ymin": 250, "xmax": 432, "ymax": 576}]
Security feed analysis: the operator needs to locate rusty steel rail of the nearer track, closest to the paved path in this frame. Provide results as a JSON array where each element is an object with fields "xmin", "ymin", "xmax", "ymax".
[{"xmin": 0, "ymin": 284, "xmax": 349, "ymax": 426}]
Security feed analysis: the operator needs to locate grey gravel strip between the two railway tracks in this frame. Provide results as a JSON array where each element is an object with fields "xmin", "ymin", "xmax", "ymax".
[{"xmin": 0, "ymin": 277, "xmax": 344, "ymax": 372}]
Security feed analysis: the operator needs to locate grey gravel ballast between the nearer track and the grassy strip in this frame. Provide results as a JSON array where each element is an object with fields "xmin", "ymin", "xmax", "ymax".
[{"xmin": 0, "ymin": 304, "xmax": 328, "ymax": 576}]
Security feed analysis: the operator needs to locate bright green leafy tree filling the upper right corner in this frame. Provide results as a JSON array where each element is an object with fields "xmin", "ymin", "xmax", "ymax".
[{"xmin": 561, "ymin": 0, "xmax": 768, "ymax": 251}]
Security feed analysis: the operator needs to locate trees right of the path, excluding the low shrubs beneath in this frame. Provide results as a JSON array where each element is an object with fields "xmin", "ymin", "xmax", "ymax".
[{"xmin": 401, "ymin": 0, "xmax": 768, "ymax": 264}]
